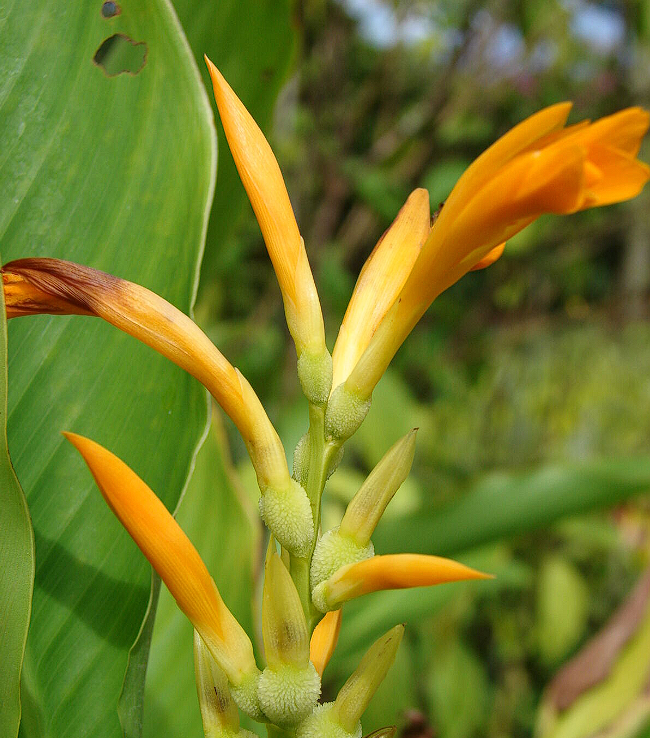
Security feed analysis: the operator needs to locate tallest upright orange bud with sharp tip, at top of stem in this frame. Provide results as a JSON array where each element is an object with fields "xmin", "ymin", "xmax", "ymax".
[{"xmin": 204, "ymin": 56, "xmax": 325, "ymax": 355}]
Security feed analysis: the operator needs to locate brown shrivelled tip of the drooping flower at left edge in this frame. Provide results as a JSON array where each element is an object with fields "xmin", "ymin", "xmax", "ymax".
[{"xmin": 2, "ymin": 258, "xmax": 122, "ymax": 318}]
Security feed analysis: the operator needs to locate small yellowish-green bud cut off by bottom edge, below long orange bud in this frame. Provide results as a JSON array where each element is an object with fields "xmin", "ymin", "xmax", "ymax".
[{"xmin": 194, "ymin": 630, "xmax": 255, "ymax": 738}]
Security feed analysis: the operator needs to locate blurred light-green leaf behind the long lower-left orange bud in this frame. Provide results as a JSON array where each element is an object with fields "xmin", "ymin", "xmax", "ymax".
[{"xmin": 144, "ymin": 416, "xmax": 261, "ymax": 738}]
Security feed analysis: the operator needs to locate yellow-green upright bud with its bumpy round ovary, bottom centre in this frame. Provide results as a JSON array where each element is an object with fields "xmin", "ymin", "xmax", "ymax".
[{"xmin": 257, "ymin": 544, "xmax": 320, "ymax": 726}]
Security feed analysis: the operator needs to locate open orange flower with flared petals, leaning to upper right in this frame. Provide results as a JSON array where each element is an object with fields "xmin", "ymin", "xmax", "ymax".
[{"xmin": 346, "ymin": 103, "xmax": 650, "ymax": 399}]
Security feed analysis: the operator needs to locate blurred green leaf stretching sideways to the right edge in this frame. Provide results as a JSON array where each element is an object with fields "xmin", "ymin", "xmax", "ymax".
[{"xmin": 373, "ymin": 457, "xmax": 650, "ymax": 556}]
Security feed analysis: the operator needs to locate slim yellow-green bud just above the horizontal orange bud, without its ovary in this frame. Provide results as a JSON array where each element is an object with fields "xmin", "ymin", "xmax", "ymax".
[{"xmin": 339, "ymin": 428, "xmax": 417, "ymax": 546}]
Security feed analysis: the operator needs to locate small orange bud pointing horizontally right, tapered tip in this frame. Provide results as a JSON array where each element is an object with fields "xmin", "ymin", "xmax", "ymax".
[{"xmin": 312, "ymin": 554, "xmax": 492, "ymax": 612}]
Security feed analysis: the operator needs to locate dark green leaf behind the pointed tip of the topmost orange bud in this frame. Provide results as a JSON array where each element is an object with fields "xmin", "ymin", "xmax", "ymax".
[{"xmin": 174, "ymin": 0, "xmax": 296, "ymax": 288}]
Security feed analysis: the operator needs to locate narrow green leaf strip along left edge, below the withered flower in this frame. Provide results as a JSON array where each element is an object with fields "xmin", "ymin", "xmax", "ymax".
[{"xmin": 0, "ymin": 274, "xmax": 34, "ymax": 738}]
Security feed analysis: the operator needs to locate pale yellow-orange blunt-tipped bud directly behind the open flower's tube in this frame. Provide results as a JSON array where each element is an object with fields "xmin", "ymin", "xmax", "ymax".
[{"xmin": 332, "ymin": 188, "xmax": 431, "ymax": 388}]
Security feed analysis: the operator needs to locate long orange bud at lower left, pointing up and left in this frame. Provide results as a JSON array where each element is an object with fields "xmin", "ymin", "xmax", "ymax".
[{"xmin": 64, "ymin": 433, "xmax": 257, "ymax": 684}]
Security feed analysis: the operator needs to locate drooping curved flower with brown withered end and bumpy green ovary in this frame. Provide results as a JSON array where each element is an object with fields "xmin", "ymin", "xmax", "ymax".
[{"xmin": 2, "ymin": 258, "xmax": 313, "ymax": 552}]
